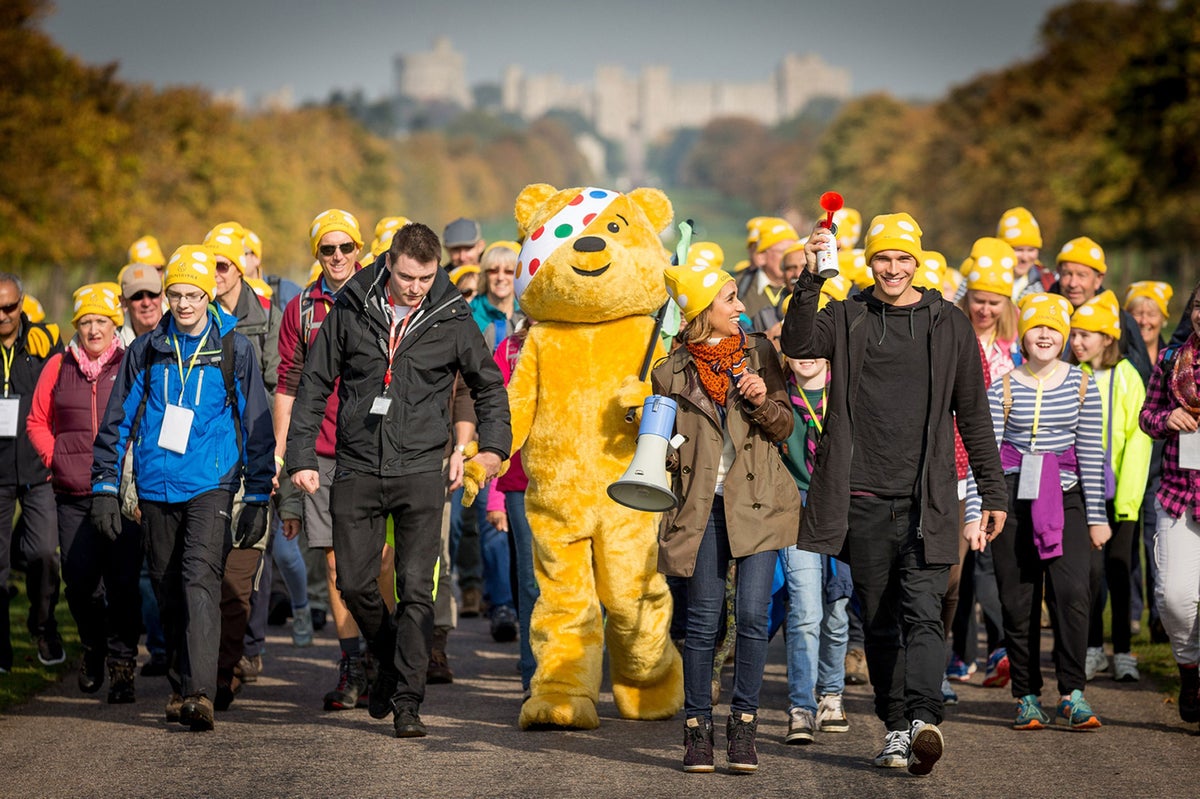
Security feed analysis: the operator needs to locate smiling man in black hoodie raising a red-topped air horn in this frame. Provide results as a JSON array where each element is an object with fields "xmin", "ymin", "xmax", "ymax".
[{"xmin": 780, "ymin": 214, "xmax": 1008, "ymax": 775}]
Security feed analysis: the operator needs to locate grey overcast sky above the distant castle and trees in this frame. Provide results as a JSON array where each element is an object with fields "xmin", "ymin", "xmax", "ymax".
[{"xmin": 43, "ymin": 0, "xmax": 1061, "ymax": 101}]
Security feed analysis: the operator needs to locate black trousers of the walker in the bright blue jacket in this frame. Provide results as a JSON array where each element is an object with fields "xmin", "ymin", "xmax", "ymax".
[{"xmin": 140, "ymin": 491, "xmax": 233, "ymax": 697}]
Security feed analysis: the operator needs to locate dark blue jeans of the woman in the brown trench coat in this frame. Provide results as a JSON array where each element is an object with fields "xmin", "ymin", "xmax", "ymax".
[{"xmin": 683, "ymin": 497, "xmax": 778, "ymax": 719}]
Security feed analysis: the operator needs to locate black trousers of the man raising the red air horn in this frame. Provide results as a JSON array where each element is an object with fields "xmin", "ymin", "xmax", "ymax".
[{"xmin": 847, "ymin": 495, "xmax": 950, "ymax": 731}]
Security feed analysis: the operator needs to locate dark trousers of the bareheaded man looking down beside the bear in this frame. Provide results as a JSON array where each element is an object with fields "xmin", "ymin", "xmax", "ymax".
[{"xmin": 329, "ymin": 471, "xmax": 445, "ymax": 705}]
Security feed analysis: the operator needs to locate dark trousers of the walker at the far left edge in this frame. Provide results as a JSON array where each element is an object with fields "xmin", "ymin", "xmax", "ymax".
[{"xmin": 0, "ymin": 482, "xmax": 60, "ymax": 668}]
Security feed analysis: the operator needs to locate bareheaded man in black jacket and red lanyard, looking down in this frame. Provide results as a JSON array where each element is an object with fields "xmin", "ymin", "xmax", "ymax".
[{"xmin": 286, "ymin": 222, "xmax": 512, "ymax": 738}]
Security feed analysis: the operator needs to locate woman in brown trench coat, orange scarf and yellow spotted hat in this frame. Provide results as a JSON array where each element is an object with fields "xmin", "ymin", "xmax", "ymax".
[{"xmin": 652, "ymin": 266, "xmax": 800, "ymax": 771}]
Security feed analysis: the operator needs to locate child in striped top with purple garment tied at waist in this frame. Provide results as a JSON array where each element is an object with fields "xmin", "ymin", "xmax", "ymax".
[{"xmin": 962, "ymin": 294, "xmax": 1111, "ymax": 729}]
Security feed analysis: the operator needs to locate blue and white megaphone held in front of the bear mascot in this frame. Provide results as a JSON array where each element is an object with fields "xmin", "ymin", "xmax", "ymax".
[{"xmin": 608, "ymin": 395, "xmax": 686, "ymax": 513}]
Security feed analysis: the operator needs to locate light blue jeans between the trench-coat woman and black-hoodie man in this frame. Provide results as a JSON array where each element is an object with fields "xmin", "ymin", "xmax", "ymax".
[{"xmin": 779, "ymin": 546, "xmax": 850, "ymax": 713}]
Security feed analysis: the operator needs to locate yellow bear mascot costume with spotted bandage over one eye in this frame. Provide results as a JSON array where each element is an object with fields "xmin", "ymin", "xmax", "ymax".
[{"xmin": 509, "ymin": 184, "xmax": 683, "ymax": 729}]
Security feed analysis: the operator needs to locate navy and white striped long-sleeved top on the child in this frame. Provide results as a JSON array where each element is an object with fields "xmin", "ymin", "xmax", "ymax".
[{"xmin": 966, "ymin": 366, "xmax": 1109, "ymax": 524}]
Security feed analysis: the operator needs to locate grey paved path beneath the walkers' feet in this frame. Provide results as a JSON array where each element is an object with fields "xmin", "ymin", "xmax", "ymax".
[{"xmin": 0, "ymin": 611, "xmax": 1200, "ymax": 799}]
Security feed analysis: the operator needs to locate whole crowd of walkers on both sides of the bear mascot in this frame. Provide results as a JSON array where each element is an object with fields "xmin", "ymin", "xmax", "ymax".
[{"xmin": 0, "ymin": 200, "xmax": 1200, "ymax": 775}]
